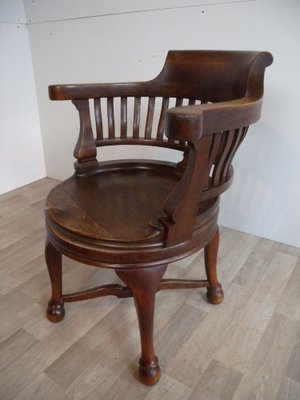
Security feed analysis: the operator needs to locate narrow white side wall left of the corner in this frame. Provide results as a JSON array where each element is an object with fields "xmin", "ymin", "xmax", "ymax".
[{"xmin": 0, "ymin": 0, "xmax": 46, "ymax": 194}]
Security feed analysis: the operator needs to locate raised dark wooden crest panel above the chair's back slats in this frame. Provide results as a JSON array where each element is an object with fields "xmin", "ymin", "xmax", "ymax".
[{"xmin": 153, "ymin": 50, "xmax": 269, "ymax": 103}]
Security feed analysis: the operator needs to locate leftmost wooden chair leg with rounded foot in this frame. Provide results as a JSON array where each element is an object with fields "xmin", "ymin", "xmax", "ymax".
[{"xmin": 45, "ymin": 239, "xmax": 65, "ymax": 322}]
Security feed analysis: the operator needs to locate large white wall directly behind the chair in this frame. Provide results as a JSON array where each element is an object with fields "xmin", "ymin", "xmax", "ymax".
[{"xmin": 24, "ymin": 0, "xmax": 300, "ymax": 246}]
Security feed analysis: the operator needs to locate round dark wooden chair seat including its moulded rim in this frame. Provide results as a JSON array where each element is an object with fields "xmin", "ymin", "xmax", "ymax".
[{"xmin": 45, "ymin": 160, "xmax": 218, "ymax": 268}]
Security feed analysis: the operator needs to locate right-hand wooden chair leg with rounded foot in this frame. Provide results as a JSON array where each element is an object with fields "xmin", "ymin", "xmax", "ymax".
[{"xmin": 204, "ymin": 228, "xmax": 224, "ymax": 304}]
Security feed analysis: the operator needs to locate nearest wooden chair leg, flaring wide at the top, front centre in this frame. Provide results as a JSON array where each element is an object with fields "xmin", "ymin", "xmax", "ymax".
[{"xmin": 116, "ymin": 265, "xmax": 167, "ymax": 385}]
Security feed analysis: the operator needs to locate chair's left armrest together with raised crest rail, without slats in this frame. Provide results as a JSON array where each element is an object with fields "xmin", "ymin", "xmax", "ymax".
[{"xmin": 49, "ymin": 50, "xmax": 272, "ymax": 102}]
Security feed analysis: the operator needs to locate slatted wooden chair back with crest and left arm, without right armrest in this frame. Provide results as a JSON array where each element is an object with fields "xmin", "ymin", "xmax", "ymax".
[{"xmin": 49, "ymin": 50, "xmax": 271, "ymax": 180}]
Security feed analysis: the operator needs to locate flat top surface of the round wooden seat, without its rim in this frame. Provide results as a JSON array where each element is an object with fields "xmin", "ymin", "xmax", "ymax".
[{"xmin": 46, "ymin": 162, "xmax": 179, "ymax": 245}]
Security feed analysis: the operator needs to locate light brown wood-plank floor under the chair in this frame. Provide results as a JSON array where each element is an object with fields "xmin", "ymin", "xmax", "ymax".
[{"xmin": 0, "ymin": 179, "xmax": 300, "ymax": 400}]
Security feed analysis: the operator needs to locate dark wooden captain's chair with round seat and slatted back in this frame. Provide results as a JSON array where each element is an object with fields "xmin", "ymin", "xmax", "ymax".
[{"xmin": 45, "ymin": 51, "xmax": 272, "ymax": 385}]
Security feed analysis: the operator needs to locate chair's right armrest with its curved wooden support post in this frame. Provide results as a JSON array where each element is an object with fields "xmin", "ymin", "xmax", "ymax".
[{"xmin": 162, "ymin": 97, "xmax": 261, "ymax": 246}]
